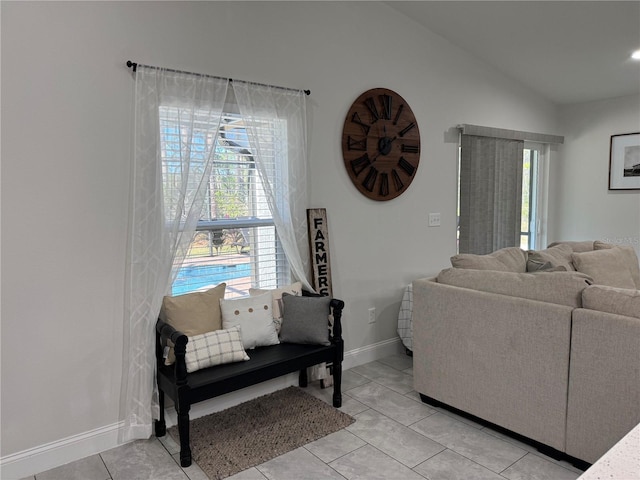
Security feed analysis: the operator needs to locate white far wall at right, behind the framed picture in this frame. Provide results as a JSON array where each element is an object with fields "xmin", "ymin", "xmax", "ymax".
[{"xmin": 549, "ymin": 95, "xmax": 640, "ymax": 253}]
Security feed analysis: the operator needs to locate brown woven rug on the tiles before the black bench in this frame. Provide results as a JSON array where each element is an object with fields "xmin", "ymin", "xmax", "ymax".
[{"xmin": 169, "ymin": 387, "xmax": 355, "ymax": 480}]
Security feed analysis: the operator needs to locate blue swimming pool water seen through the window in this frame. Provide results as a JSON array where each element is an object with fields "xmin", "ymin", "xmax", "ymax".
[{"xmin": 171, "ymin": 263, "xmax": 251, "ymax": 295}]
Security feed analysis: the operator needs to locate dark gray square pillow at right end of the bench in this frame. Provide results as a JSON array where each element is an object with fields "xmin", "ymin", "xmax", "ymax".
[{"xmin": 280, "ymin": 293, "xmax": 331, "ymax": 345}]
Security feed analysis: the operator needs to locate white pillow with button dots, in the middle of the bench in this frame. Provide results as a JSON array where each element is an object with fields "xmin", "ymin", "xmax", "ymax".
[{"xmin": 220, "ymin": 292, "xmax": 280, "ymax": 350}]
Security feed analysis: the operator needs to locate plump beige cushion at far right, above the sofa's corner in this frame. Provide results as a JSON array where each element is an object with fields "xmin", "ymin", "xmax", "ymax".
[{"xmin": 571, "ymin": 248, "xmax": 636, "ymax": 289}]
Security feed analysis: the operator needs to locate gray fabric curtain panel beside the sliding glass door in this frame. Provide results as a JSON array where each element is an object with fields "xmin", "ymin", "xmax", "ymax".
[{"xmin": 458, "ymin": 135, "xmax": 524, "ymax": 254}]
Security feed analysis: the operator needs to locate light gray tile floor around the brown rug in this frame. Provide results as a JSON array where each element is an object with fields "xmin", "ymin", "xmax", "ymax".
[{"xmin": 27, "ymin": 355, "xmax": 582, "ymax": 480}]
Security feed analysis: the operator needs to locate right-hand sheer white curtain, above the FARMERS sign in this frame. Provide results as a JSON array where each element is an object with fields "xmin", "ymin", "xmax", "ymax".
[{"xmin": 232, "ymin": 80, "xmax": 313, "ymax": 291}]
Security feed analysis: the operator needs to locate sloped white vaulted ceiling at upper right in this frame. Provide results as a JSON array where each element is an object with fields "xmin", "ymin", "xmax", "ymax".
[{"xmin": 386, "ymin": 0, "xmax": 640, "ymax": 104}]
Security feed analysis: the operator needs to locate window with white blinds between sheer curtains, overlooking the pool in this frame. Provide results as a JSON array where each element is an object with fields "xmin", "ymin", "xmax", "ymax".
[{"xmin": 160, "ymin": 106, "xmax": 290, "ymax": 298}]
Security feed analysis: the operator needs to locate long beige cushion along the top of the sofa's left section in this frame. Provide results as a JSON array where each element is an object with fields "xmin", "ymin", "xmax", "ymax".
[{"xmin": 437, "ymin": 268, "xmax": 592, "ymax": 308}]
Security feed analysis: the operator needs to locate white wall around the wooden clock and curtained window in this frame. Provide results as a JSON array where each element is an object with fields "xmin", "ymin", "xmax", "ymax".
[{"xmin": 1, "ymin": 2, "xmax": 558, "ymax": 470}]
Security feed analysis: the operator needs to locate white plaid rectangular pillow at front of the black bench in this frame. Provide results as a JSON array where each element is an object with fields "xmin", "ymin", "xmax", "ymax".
[{"xmin": 184, "ymin": 327, "xmax": 249, "ymax": 373}]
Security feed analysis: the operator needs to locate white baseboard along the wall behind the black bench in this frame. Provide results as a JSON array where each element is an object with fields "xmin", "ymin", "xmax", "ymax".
[{"xmin": 0, "ymin": 338, "xmax": 404, "ymax": 480}]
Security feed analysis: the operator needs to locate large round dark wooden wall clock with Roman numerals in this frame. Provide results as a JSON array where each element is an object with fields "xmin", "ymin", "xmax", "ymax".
[{"xmin": 342, "ymin": 88, "xmax": 420, "ymax": 201}]
